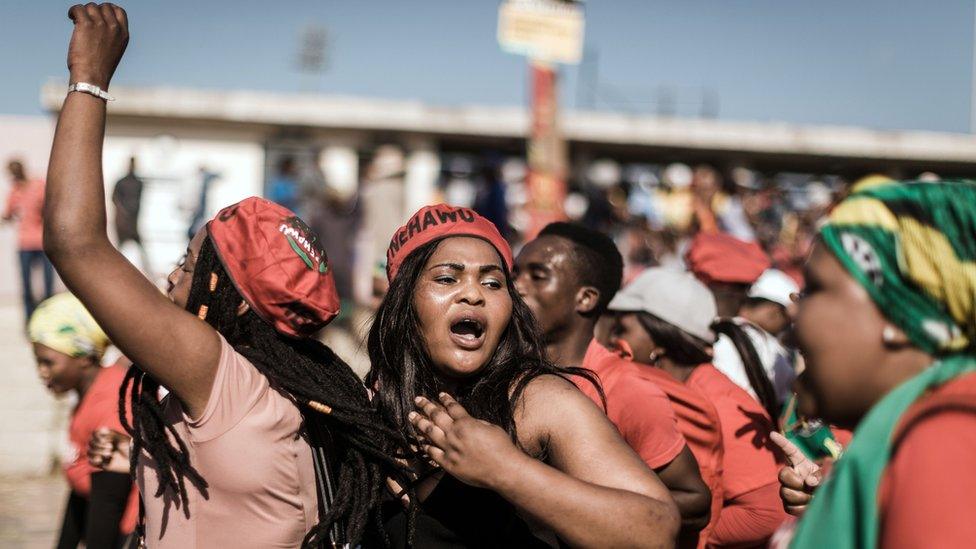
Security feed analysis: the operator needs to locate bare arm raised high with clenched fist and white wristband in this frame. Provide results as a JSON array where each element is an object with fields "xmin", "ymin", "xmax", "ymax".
[{"xmin": 44, "ymin": 4, "xmax": 220, "ymax": 415}]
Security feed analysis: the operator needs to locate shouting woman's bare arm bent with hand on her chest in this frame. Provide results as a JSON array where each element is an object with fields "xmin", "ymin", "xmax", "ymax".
[{"xmin": 413, "ymin": 376, "xmax": 680, "ymax": 547}]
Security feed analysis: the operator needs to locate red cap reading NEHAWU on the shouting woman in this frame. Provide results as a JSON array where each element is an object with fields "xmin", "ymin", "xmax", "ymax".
[{"xmin": 386, "ymin": 204, "xmax": 512, "ymax": 281}]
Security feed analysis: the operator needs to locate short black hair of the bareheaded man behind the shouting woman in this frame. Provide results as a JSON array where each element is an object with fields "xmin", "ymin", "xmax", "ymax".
[{"xmin": 539, "ymin": 221, "xmax": 624, "ymax": 317}]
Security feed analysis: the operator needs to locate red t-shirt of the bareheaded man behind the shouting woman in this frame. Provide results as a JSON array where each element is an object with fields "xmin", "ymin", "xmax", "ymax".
[{"xmin": 573, "ymin": 339, "xmax": 685, "ymax": 469}]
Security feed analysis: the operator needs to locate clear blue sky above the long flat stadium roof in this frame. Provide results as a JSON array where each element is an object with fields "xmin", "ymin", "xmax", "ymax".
[{"xmin": 0, "ymin": 0, "xmax": 974, "ymax": 132}]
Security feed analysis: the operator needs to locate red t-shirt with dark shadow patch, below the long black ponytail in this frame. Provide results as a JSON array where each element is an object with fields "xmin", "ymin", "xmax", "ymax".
[{"xmin": 687, "ymin": 364, "xmax": 786, "ymax": 544}]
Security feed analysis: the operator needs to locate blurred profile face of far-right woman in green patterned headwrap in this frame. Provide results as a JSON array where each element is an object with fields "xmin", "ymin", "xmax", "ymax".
[{"xmin": 795, "ymin": 244, "xmax": 885, "ymax": 427}]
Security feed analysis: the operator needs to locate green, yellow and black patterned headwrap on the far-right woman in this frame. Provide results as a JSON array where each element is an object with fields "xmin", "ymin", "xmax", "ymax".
[{"xmin": 821, "ymin": 181, "xmax": 976, "ymax": 355}]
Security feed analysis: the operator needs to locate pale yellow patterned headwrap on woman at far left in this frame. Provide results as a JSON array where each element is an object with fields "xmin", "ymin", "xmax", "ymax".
[{"xmin": 27, "ymin": 292, "xmax": 109, "ymax": 358}]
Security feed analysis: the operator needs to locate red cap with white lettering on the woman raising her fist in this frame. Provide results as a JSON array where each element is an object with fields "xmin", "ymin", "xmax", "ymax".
[{"xmin": 207, "ymin": 196, "xmax": 339, "ymax": 337}]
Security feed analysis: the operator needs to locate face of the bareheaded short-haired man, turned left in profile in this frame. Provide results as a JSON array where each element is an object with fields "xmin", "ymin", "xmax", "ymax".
[{"xmin": 512, "ymin": 235, "xmax": 579, "ymax": 339}]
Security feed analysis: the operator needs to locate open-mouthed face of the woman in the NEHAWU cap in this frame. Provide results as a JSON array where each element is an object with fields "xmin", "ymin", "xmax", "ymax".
[{"xmin": 412, "ymin": 237, "xmax": 512, "ymax": 380}]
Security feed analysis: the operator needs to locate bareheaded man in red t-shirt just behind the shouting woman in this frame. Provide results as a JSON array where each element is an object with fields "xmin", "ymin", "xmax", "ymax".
[{"xmin": 513, "ymin": 223, "xmax": 711, "ymax": 546}]
